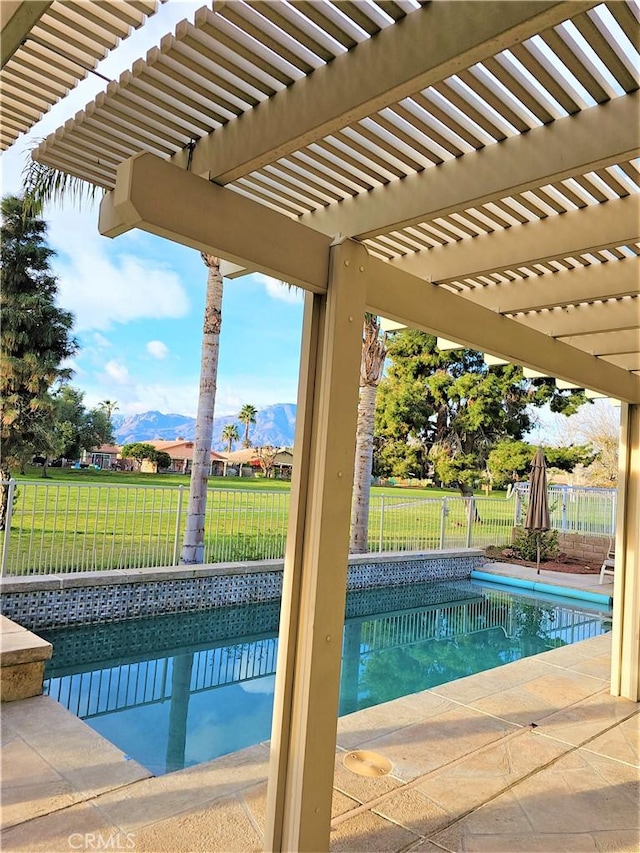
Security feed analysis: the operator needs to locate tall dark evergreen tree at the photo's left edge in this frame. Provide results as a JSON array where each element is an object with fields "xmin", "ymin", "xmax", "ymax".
[{"xmin": 0, "ymin": 196, "xmax": 77, "ymax": 523}]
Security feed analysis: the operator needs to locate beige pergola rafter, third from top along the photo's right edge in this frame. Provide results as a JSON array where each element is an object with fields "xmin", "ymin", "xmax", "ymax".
[{"xmin": 460, "ymin": 258, "xmax": 640, "ymax": 314}]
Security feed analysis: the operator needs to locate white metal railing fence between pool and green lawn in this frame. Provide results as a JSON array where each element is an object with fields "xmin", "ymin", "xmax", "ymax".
[{"xmin": 0, "ymin": 480, "xmax": 615, "ymax": 575}]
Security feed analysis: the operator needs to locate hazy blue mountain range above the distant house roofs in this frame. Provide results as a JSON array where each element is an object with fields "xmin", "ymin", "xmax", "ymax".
[{"xmin": 113, "ymin": 403, "xmax": 296, "ymax": 450}]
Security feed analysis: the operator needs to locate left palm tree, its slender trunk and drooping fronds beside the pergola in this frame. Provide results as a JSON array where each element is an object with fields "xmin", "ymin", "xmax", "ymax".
[{"xmin": 23, "ymin": 159, "xmax": 223, "ymax": 564}]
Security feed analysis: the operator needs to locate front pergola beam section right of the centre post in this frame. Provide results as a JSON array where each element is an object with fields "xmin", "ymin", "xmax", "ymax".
[{"xmin": 367, "ymin": 258, "xmax": 640, "ymax": 402}]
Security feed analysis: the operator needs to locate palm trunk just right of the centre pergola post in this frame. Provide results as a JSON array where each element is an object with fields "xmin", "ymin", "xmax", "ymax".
[{"xmin": 349, "ymin": 314, "xmax": 387, "ymax": 554}]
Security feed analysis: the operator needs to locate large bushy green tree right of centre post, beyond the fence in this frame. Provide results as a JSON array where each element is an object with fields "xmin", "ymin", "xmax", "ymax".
[{"xmin": 375, "ymin": 329, "xmax": 585, "ymax": 494}]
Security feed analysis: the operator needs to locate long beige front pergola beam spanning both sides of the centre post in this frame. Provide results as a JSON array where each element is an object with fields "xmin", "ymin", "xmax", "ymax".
[{"xmin": 100, "ymin": 154, "xmax": 640, "ymax": 402}]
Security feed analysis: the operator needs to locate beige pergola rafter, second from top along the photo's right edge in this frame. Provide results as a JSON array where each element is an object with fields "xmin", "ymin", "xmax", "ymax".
[{"xmin": 389, "ymin": 195, "xmax": 640, "ymax": 282}]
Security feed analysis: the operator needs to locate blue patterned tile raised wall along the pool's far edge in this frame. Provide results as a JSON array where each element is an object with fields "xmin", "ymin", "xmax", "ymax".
[{"xmin": 0, "ymin": 549, "xmax": 486, "ymax": 630}]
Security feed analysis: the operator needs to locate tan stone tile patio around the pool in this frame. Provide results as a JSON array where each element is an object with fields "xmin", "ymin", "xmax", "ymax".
[{"xmin": 2, "ymin": 567, "xmax": 640, "ymax": 853}]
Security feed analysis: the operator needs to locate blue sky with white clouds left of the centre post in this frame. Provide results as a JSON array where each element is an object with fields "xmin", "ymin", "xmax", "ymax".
[{"xmin": 1, "ymin": 0, "xmax": 302, "ymax": 415}]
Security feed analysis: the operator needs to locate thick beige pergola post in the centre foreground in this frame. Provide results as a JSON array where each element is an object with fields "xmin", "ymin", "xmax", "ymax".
[{"xmin": 265, "ymin": 236, "xmax": 368, "ymax": 853}]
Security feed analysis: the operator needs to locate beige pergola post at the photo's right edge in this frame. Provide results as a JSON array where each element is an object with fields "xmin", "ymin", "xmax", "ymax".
[{"xmin": 611, "ymin": 403, "xmax": 640, "ymax": 702}]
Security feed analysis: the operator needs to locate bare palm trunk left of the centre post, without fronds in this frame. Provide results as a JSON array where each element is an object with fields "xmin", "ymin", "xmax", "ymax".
[{"xmin": 180, "ymin": 260, "xmax": 223, "ymax": 564}]
